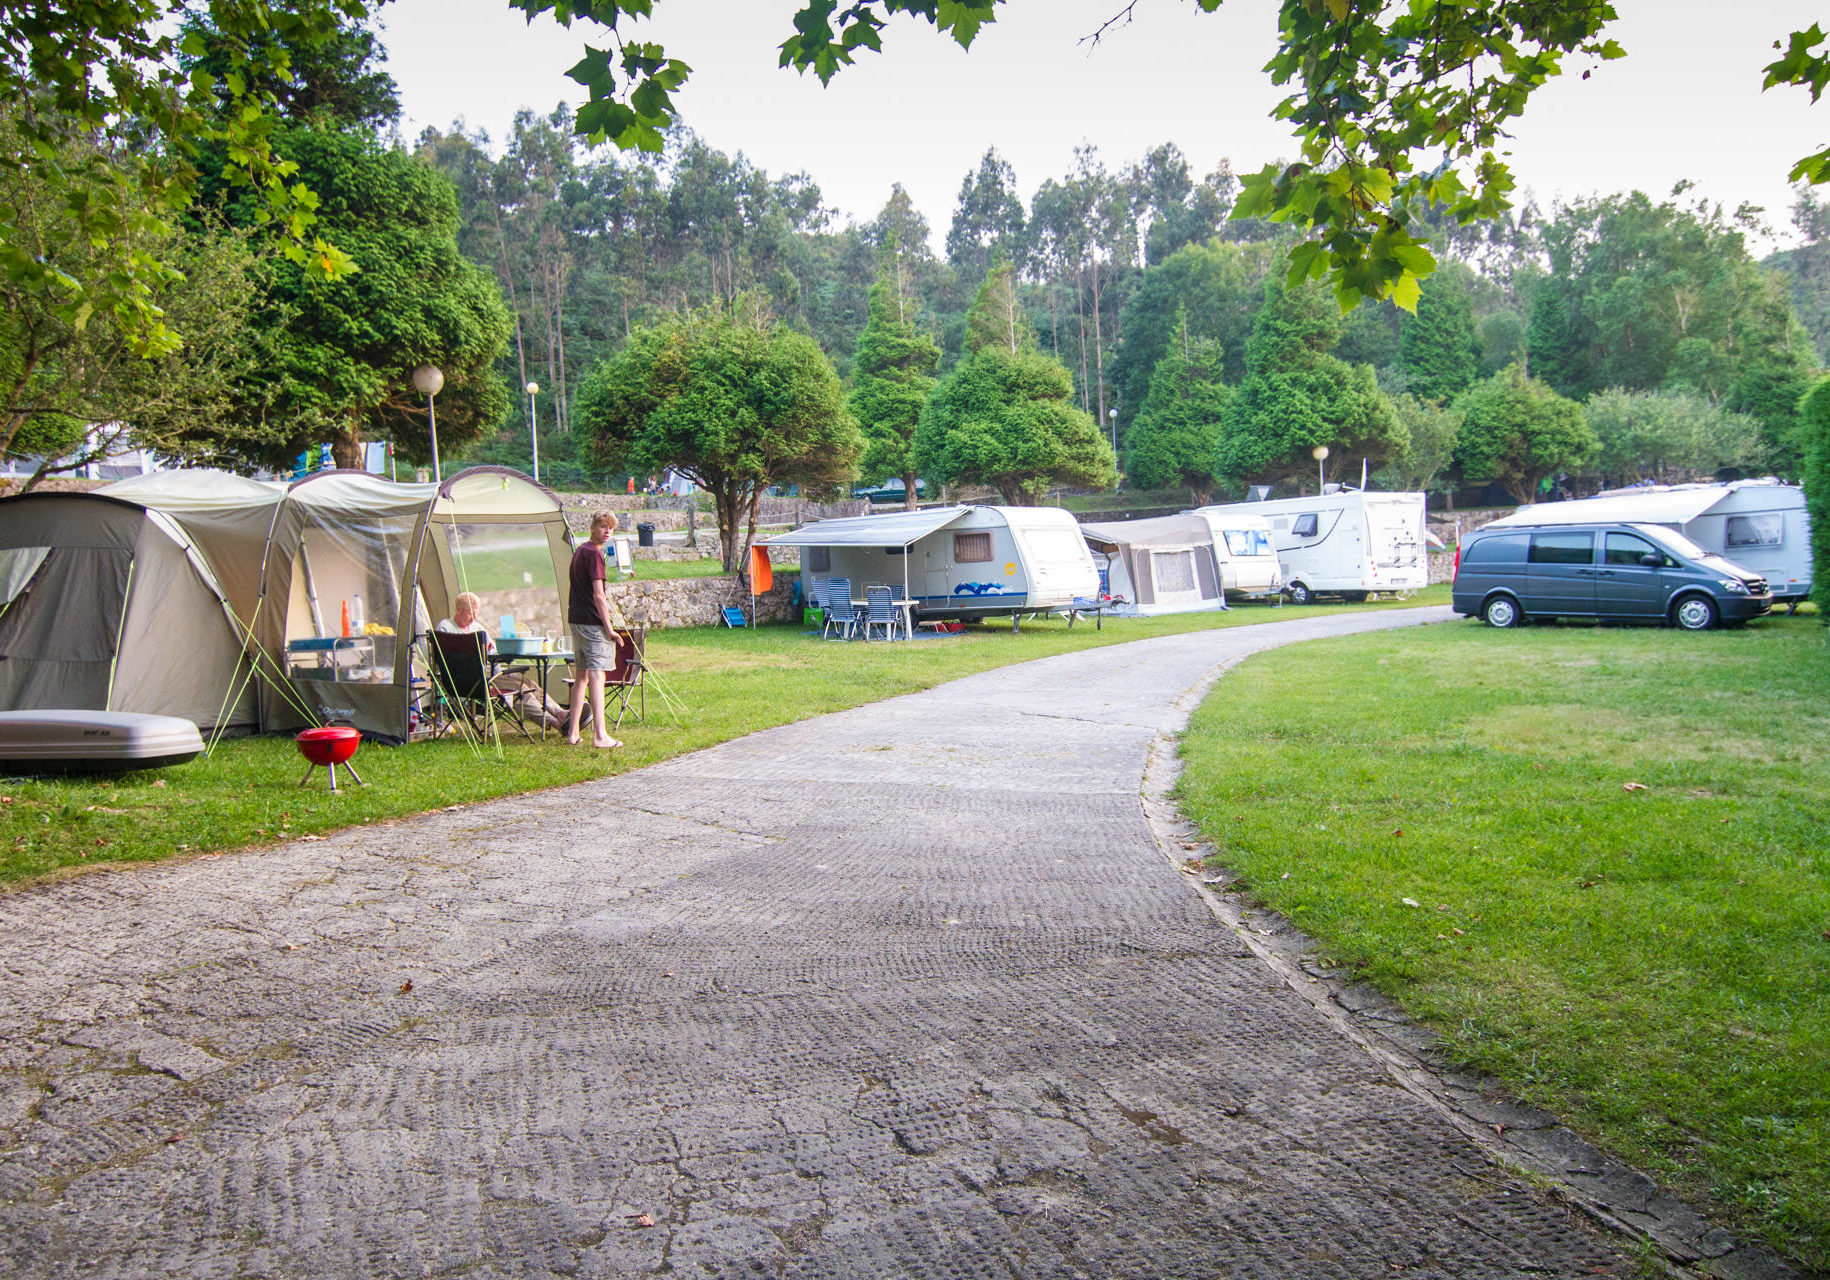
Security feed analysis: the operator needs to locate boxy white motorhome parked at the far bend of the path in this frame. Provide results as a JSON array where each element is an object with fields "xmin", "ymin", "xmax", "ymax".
[{"xmin": 1197, "ymin": 485, "xmax": 1429, "ymax": 604}]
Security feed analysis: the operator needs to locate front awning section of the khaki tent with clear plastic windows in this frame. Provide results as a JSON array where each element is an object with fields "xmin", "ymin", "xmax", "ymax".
[{"xmin": 82, "ymin": 467, "xmax": 571, "ymax": 740}]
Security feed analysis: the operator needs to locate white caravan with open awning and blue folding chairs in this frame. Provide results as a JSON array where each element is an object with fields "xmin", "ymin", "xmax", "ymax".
[{"xmin": 758, "ymin": 507, "xmax": 1100, "ymax": 621}]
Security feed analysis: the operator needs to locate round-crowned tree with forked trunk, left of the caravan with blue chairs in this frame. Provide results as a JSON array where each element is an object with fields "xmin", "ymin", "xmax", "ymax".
[{"xmin": 578, "ymin": 297, "xmax": 864, "ymax": 571}]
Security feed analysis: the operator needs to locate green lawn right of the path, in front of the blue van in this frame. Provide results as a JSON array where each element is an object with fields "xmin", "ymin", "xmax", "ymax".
[{"xmin": 1182, "ymin": 615, "xmax": 1830, "ymax": 1267}]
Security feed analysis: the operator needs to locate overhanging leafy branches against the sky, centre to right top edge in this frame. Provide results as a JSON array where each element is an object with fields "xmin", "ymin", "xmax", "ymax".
[{"xmin": 512, "ymin": 0, "xmax": 1830, "ymax": 311}]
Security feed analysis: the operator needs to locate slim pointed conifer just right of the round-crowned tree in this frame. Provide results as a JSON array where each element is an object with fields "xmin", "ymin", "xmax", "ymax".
[{"xmin": 845, "ymin": 242, "xmax": 941, "ymax": 511}]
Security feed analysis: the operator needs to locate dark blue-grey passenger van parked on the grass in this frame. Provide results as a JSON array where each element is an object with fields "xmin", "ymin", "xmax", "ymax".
[{"xmin": 1453, "ymin": 520, "xmax": 1773, "ymax": 632}]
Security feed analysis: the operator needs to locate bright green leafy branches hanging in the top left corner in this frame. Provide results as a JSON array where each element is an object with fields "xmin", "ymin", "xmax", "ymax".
[{"xmin": 0, "ymin": 0, "xmax": 368, "ymax": 357}]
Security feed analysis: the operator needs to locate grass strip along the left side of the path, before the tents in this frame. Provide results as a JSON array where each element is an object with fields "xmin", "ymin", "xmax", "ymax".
[{"xmin": 0, "ymin": 589, "xmax": 1448, "ymax": 886}]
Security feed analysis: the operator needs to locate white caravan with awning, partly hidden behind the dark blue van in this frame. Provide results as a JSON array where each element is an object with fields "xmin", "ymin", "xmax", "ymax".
[{"xmin": 1493, "ymin": 476, "xmax": 1812, "ymax": 610}]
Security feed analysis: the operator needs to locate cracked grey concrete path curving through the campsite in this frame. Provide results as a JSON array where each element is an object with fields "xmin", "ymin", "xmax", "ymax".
[{"xmin": 0, "ymin": 610, "xmax": 1632, "ymax": 1280}]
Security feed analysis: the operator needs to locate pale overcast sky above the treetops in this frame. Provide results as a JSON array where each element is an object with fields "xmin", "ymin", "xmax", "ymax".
[{"xmin": 381, "ymin": 0, "xmax": 1830, "ymax": 253}]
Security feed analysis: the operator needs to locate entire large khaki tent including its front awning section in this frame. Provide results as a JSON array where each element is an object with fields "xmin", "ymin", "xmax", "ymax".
[{"xmin": 0, "ymin": 467, "xmax": 571, "ymax": 740}]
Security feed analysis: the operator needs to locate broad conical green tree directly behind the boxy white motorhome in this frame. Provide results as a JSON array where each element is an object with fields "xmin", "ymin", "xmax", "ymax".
[{"xmin": 1215, "ymin": 278, "xmax": 1405, "ymax": 483}]
